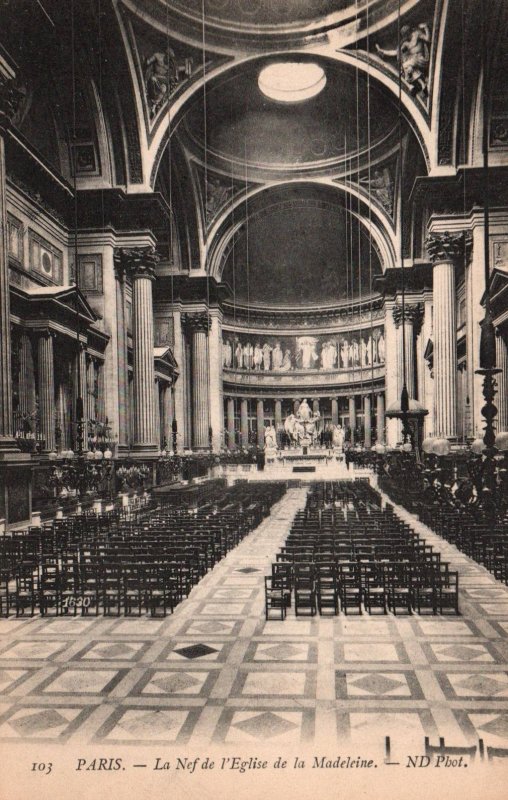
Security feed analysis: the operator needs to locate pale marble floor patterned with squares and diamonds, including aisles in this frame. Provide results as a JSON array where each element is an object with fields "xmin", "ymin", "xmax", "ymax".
[{"xmin": 0, "ymin": 488, "xmax": 508, "ymax": 757}]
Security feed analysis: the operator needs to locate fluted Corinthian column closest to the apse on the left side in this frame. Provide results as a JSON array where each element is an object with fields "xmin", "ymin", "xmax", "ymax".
[{"xmin": 182, "ymin": 312, "xmax": 210, "ymax": 450}]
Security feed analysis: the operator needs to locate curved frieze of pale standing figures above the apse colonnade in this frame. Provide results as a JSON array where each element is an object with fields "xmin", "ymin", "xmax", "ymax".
[{"xmin": 222, "ymin": 326, "xmax": 385, "ymax": 373}]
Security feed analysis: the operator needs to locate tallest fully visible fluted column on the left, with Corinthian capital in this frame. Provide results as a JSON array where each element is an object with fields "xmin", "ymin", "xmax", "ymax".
[{"xmin": 122, "ymin": 247, "xmax": 158, "ymax": 453}]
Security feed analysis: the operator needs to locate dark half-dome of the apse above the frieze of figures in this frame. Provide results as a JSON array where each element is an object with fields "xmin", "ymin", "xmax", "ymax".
[{"xmin": 222, "ymin": 184, "xmax": 381, "ymax": 307}]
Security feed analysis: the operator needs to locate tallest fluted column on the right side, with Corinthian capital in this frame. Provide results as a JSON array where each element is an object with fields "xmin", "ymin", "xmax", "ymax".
[{"xmin": 427, "ymin": 232, "xmax": 464, "ymax": 438}]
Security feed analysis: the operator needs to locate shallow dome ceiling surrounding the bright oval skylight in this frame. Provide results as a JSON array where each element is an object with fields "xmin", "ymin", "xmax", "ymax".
[{"xmin": 178, "ymin": 55, "xmax": 397, "ymax": 173}]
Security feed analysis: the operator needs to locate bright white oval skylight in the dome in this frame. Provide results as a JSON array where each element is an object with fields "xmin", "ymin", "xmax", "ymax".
[{"xmin": 258, "ymin": 61, "xmax": 326, "ymax": 103}]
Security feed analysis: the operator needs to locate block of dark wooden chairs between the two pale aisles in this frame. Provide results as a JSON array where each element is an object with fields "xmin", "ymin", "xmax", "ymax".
[{"xmin": 265, "ymin": 481, "xmax": 459, "ymax": 619}]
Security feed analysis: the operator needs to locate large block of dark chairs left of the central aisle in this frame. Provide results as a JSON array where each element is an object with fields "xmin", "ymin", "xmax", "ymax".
[{"xmin": 0, "ymin": 484, "xmax": 286, "ymax": 616}]
